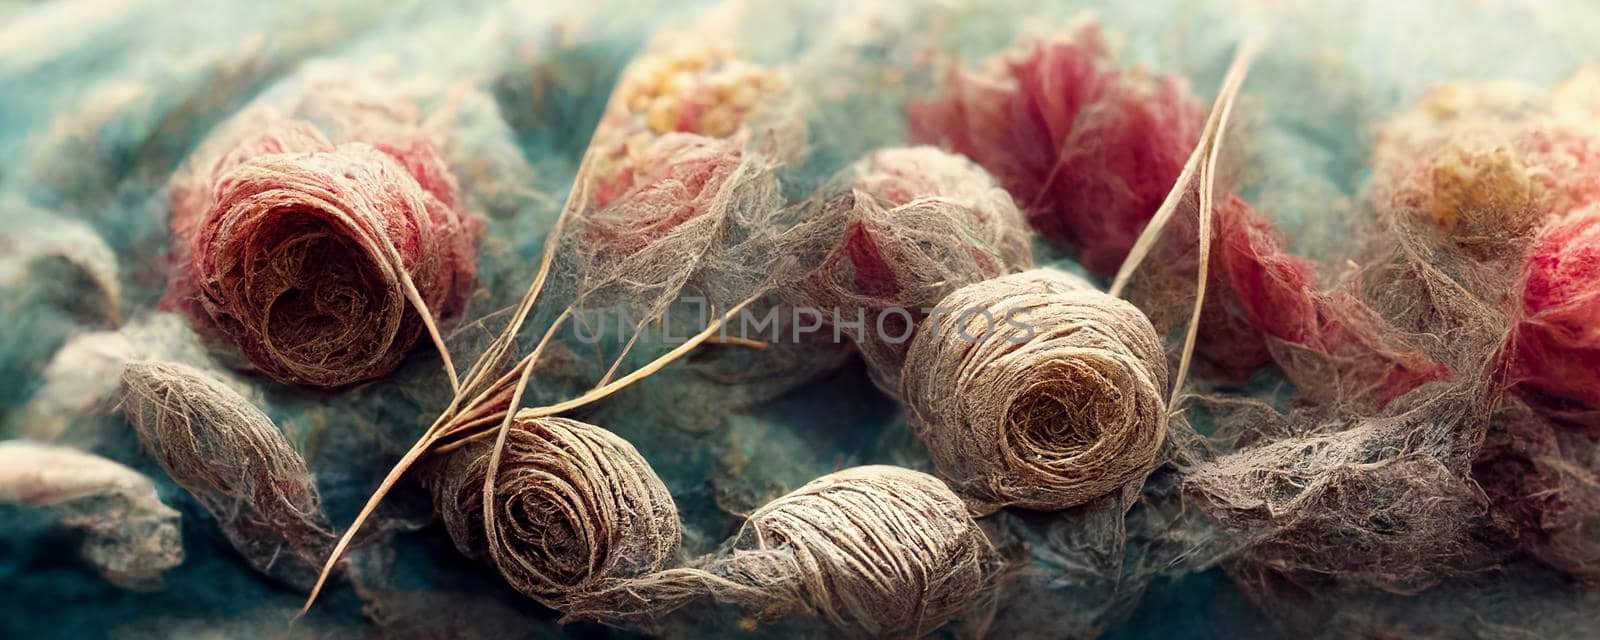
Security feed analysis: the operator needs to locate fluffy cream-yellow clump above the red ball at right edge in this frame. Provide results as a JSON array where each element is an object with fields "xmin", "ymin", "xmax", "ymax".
[{"xmin": 1373, "ymin": 67, "xmax": 1600, "ymax": 252}]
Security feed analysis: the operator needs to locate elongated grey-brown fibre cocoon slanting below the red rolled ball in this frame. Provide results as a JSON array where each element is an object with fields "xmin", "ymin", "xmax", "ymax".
[{"xmin": 122, "ymin": 362, "xmax": 334, "ymax": 589}]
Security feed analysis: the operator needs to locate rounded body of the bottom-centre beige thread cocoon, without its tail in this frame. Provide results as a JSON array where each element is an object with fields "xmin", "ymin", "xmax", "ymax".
[{"xmin": 726, "ymin": 466, "xmax": 998, "ymax": 637}]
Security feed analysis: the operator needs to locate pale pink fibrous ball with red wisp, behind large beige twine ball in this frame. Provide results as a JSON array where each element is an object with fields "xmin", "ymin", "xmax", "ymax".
[{"xmin": 797, "ymin": 147, "xmax": 1034, "ymax": 394}]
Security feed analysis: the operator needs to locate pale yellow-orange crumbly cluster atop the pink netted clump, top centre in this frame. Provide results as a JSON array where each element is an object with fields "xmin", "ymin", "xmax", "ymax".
[{"xmin": 618, "ymin": 46, "xmax": 784, "ymax": 138}]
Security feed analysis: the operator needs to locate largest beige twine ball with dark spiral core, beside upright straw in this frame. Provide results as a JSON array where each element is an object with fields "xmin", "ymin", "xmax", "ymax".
[{"xmin": 901, "ymin": 269, "xmax": 1166, "ymax": 514}]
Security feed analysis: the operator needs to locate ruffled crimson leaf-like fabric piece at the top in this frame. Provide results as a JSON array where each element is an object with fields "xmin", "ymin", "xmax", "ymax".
[{"xmin": 909, "ymin": 21, "xmax": 1202, "ymax": 275}]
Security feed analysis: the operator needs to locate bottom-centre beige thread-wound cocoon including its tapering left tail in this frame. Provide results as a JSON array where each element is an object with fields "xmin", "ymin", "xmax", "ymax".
[{"xmin": 613, "ymin": 466, "xmax": 1002, "ymax": 638}]
